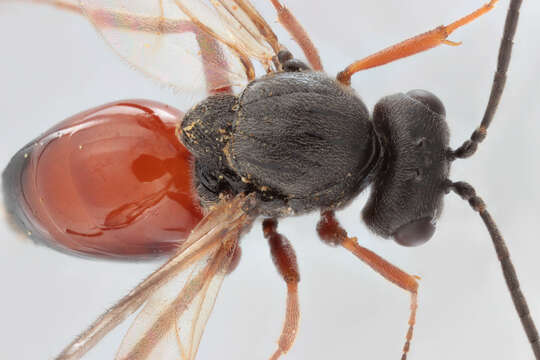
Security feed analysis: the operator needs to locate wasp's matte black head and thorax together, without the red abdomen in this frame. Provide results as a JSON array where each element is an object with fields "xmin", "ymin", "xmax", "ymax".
[{"xmin": 184, "ymin": 71, "xmax": 450, "ymax": 245}]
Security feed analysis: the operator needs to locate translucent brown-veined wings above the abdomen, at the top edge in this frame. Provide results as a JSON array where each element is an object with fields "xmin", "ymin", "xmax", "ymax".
[{"xmin": 80, "ymin": 0, "xmax": 279, "ymax": 91}]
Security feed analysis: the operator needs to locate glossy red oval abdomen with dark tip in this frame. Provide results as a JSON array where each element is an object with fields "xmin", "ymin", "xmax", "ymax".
[{"xmin": 3, "ymin": 100, "xmax": 202, "ymax": 259}]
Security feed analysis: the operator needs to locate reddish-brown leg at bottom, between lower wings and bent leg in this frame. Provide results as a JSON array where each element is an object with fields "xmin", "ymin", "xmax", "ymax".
[{"xmin": 263, "ymin": 219, "xmax": 300, "ymax": 360}]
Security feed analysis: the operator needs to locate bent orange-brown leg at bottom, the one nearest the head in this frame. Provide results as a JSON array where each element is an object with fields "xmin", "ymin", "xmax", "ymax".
[{"xmin": 317, "ymin": 211, "xmax": 418, "ymax": 360}]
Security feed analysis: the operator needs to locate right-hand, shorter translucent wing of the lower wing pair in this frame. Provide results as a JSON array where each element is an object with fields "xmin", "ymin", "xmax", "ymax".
[{"xmin": 116, "ymin": 212, "xmax": 243, "ymax": 360}]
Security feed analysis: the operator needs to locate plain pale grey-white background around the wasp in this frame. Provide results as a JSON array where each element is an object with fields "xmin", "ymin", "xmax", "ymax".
[{"xmin": 0, "ymin": 0, "xmax": 540, "ymax": 360}]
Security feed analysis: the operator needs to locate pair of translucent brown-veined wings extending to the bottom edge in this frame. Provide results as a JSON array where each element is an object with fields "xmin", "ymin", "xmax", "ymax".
[{"xmin": 57, "ymin": 194, "xmax": 256, "ymax": 360}]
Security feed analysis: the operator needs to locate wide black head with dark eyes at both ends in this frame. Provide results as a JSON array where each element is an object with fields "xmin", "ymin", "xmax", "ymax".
[{"xmin": 362, "ymin": 90, "xmax": 450, "ymax": 246}]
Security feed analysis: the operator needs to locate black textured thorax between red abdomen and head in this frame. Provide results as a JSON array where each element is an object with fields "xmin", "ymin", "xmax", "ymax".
[{"xmin": 182, "ymin": 72, "xmax": 378, "ymax": 215}]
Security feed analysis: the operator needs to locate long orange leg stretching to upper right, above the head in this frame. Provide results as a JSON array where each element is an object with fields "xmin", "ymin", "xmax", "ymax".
[{"xmin": 337, "ymin": 0, "xmax": 498, "ymax": 85}]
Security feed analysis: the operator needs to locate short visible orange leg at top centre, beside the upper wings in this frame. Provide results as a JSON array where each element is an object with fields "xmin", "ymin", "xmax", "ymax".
[{"xmin": 270, "ymin": 0, "xmax": 323, "ymax": 71}]
